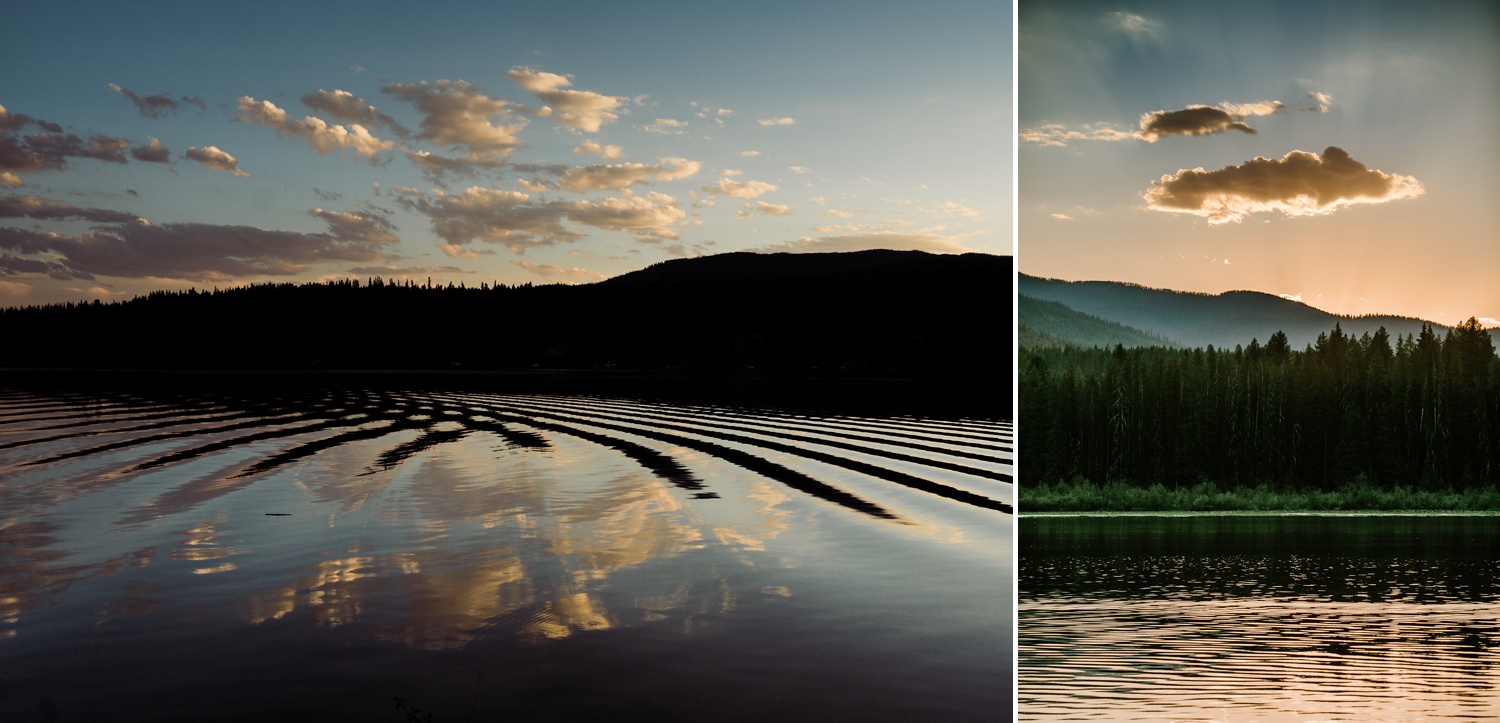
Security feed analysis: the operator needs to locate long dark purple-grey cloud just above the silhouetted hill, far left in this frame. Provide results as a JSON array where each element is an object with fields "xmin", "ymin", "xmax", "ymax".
[{"xmin": 0, "ymin": 221, "xmax": 393, "ymax": 282}]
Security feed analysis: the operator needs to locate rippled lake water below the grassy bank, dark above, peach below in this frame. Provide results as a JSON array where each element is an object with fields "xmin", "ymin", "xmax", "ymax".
[{"xmin": 1017, "ymin": 516, "xmax": 1500, "ymax": 722}]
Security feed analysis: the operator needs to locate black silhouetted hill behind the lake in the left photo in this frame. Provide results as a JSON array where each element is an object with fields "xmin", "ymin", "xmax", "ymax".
[{"xmin": 0, "ymin": 251, "xmax": 1013, "ymax": 387}]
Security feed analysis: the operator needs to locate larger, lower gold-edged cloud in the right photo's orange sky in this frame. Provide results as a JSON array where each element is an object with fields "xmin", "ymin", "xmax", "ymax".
[{"xmin": 1145, "ymin": 146, "xmax": 1425, "ymax": 225}]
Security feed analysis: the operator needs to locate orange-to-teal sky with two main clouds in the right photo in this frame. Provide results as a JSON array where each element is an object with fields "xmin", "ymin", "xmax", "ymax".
[{"xmin": 1016, "ymin": 0, "xmax": 1500, "ymax": 326}]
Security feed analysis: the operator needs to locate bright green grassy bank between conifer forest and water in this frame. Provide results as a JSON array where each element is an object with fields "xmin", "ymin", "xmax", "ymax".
[{"xmin": 1016, "ymin": 477, "xmax": 1500, "ymax": 515}]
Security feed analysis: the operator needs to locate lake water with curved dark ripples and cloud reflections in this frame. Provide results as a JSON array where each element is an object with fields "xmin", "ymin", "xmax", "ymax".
[{"xmin": 0, "ymin": 378, "xmax": 1013, "ymax": 723}]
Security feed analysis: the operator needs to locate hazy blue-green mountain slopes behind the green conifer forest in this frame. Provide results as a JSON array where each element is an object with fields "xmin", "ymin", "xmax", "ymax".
[{"xmin": 1017, "ymin": 273, "xmax": 1449, "ymax": 348}]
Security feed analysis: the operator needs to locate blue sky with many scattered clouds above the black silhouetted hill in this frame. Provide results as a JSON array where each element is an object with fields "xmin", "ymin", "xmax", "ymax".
[{"xmin": 0, "ymin": 0, "xmax": 1014, "ymax": 306}]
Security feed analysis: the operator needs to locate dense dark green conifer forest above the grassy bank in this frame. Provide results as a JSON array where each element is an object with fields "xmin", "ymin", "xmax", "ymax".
[{"xmin": 1019, "ymin": 318, "xmax": 1500, "ymax": 500}]
